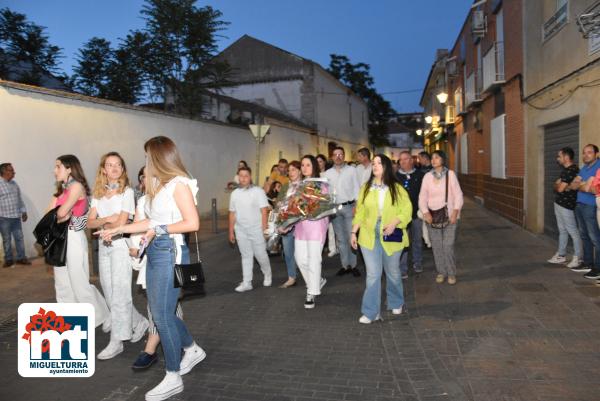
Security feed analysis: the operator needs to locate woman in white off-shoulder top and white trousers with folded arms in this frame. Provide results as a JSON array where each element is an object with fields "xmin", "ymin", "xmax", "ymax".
[{"xmin": 88, "ymin": 152, "xmax": 148, "ymax": 359}]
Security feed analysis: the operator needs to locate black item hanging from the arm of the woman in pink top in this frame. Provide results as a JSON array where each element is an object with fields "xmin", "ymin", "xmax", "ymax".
[{"xmin": 33, "ymin": 206, "xmax": 69, "ymax": 266}]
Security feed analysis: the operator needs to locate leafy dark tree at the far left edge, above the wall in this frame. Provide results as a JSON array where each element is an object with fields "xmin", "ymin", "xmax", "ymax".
[{"xmin": 0, "ymin": 8, "xmax": 61, "ymax": 85}]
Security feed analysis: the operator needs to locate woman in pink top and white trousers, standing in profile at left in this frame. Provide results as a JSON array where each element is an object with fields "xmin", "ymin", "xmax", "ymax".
[{"xmin": 50, "ymin": 155, "xmax": 110, "ymax": 327}]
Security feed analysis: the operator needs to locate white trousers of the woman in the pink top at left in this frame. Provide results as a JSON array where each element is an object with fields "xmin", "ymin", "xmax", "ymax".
[{"xmin": 54, "ymin": 230, "xmax": 109, "ymax": 327}]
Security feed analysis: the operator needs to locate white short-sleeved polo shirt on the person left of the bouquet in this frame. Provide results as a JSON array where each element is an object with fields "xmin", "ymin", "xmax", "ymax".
[{"xmin": 229, "ymin": 185, "xmax": 269, "ymax": 227}]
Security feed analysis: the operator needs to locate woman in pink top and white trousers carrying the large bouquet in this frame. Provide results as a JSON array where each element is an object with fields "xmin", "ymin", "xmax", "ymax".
[{"xmin": 294, "ymin": 155, "xmax": 329, "ymax": 309}]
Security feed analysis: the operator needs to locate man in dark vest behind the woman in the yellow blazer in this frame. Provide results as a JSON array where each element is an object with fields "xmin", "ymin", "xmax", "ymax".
[{"xmin": 396, "ymin": 151, "xmax": 425, "ymax": 278}]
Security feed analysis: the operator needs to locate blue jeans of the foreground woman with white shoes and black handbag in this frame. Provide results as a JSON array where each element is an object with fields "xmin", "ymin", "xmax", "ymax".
[{"xmin": 146, "ymin": 235, "xmax": 194, "ymax": 372}]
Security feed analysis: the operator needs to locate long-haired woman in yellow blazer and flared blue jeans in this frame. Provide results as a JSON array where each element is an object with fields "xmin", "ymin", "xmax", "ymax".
[{"xmin": 350, "ymin": 154, "xmax": 412, "ymax": 324}]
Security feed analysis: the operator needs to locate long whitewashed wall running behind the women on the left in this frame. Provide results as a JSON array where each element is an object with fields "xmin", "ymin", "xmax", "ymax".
[{"xmin": 0, "ymin": 84, "xmax": 316, "ymax": 255}]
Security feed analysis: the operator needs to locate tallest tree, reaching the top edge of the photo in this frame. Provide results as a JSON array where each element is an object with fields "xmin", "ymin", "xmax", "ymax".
[{"xmin": 141, "ymin": 0, "xmax": 228, "ymax": 115}]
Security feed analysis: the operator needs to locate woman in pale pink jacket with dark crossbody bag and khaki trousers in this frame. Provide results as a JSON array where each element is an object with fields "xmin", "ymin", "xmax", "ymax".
[{"xmin": 419, "ymin": 150, "xmax": 464, "ymax": 285}]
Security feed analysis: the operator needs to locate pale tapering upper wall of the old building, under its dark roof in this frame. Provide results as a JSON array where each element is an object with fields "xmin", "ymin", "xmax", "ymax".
[{"xmin": 221, "ymin": 80, "xmax": 302, "ymax": 118}]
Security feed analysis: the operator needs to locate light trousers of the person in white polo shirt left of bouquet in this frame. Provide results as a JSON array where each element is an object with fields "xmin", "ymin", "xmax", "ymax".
[{"xmin": 234, "ymin": 224, "xmax": 272, "ymax": 284}]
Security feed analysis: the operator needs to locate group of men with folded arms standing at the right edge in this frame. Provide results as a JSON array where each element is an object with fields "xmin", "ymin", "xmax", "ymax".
[{"xmin": 548, "ymin": 144, "xmax": 600, "ymax": 286}]
